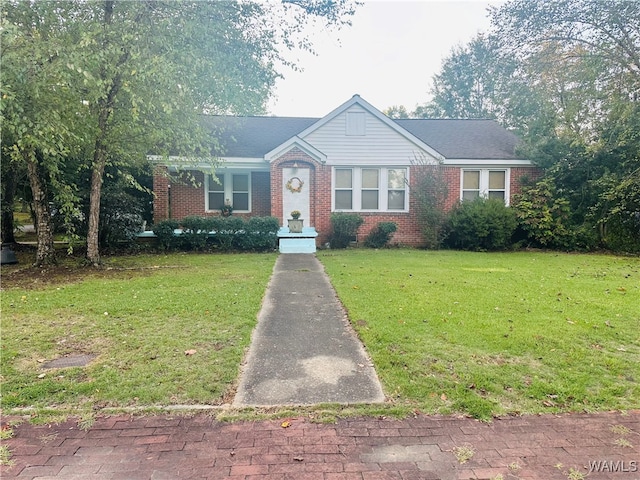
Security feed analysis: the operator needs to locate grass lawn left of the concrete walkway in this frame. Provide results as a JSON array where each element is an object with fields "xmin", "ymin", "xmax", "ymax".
[{"xmin": 1, "ymin": 254, "xmax": 275, "ymax": 411}]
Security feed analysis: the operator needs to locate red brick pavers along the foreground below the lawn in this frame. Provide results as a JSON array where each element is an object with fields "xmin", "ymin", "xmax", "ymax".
[{"xmin": 0, "ymin": 411, "xmax": 640, "ymax": 480}]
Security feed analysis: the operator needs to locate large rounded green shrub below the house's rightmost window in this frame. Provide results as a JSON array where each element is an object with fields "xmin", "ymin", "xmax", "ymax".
[{"xmin": 447, "ymin": 198, "xmax": 516, "ymax": 251}]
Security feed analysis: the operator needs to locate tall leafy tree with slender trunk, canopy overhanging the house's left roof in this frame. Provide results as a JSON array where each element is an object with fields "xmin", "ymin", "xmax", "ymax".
[{"xmin": 3, "ymin": 0, "xmax": 354, "ymax": 265}]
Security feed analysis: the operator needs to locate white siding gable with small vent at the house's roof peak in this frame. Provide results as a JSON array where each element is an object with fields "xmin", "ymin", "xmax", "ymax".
[{"xmin": 303, "ymin": 103, "xmax": 434, "ymax": 166}]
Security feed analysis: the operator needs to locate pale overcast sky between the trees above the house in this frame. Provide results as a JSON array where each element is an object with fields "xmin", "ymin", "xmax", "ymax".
[{"xmin": 268, "ymin": 0, "xmax": 503, "ymax": 117}]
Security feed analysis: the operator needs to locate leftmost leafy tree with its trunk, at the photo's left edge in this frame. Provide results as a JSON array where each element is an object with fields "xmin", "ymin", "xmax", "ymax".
[{"xmin": 0, "ymin": 3, "xmax": 82, "ymax": 265}]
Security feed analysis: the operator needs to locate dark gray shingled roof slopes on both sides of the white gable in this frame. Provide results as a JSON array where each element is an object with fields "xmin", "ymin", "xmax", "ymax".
[{"xmin": 204, "ymin": 116, "xmax": 519, "ymax": 160}]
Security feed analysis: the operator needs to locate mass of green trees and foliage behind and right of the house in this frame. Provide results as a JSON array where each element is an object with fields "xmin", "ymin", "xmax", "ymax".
[{"xmin": 414, "ymin": 0, "xmax": 640, "ymax": 251}]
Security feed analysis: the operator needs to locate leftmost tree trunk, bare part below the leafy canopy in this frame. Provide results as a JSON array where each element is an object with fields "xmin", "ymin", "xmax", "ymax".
[{"xmin": 23, "ymin": 150, "xmax": 57, "ymax": 267}]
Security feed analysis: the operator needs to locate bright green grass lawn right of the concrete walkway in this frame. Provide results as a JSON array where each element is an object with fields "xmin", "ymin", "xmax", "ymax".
[{"xmin": 318, "ymin": 249, "xmax": 640, "ymax": 418}]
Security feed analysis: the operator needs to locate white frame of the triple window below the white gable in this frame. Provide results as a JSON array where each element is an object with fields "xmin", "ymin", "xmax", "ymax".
[{"xmin": 331, "ymin": 166, "xmax": 410, "ymax": 213}]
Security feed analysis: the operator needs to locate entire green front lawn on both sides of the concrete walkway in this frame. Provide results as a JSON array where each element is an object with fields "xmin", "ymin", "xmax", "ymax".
[{"xmin": 0, "ymin": 249, "xmax": 640, "ymax": 418}]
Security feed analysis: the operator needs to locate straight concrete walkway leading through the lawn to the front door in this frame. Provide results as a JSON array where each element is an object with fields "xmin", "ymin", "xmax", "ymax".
[{"xmin": 233, "ymin": 254, "xmax": 384, "ymax": 406}]
